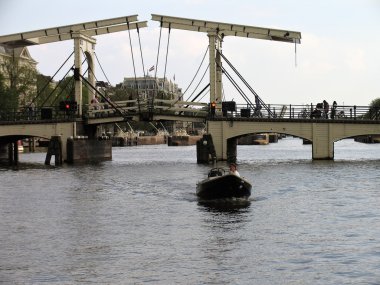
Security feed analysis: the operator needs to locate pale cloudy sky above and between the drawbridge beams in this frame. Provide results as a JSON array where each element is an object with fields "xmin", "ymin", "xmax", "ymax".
[{"xmin": 0, "ymin": 0, "xmax": 380, "ymax": 106}]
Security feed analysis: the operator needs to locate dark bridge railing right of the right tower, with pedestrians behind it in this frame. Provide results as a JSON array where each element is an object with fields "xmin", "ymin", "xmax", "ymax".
[{"xmin": 223, "ymin": 104, "xmax": 380, "ymax": 121}]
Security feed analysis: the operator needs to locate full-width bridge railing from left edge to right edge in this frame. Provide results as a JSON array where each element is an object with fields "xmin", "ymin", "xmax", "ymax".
[{"xmin": 0, "ymin": 99, "xmax": 380, "ymax": 122}]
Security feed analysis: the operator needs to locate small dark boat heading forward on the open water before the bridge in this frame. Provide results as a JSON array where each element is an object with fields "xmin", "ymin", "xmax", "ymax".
[{"xmin": 196, "ymin": 168, "xmax": 252, "ymax": 199}]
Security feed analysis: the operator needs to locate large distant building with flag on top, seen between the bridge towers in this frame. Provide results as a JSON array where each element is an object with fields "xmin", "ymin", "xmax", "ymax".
[{"xmin": 122, "ymin": 75, "xmax": 183, "ymax": 100}]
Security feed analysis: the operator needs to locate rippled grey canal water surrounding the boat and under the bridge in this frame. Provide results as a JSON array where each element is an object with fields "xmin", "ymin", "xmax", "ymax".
[{"xmin": 0, "ymin": 138, "xmax": 380, "ymax": 285}]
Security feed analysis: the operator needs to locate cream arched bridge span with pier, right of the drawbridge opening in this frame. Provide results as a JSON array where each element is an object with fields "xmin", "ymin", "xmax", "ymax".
[{"xmin": 207, "ymin": 120, "xmax": 380, "ymax": 160}]
